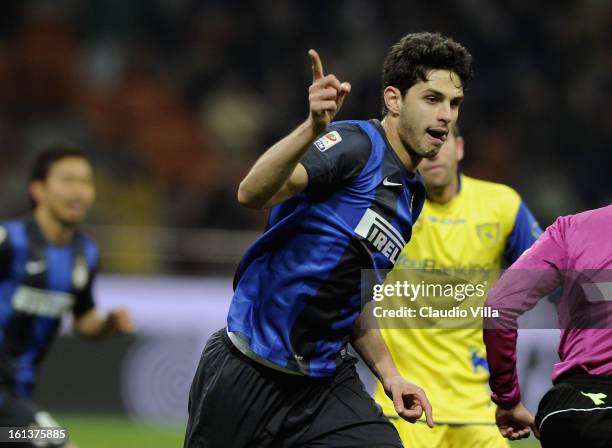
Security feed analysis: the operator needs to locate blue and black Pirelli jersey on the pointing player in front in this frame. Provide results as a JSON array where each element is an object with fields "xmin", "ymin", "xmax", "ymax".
[{"xmin": 228, "ymin": 120, "xmax": 425, "ymax": 376}]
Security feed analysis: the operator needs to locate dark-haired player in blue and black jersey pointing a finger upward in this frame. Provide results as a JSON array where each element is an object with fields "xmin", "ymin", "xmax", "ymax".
[{"xmin": 185, "ymin": 33, "xmax": 472, "ymax": 448}]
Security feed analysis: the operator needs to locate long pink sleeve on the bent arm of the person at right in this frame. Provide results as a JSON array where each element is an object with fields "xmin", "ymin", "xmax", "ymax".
[{"xmin": 483, "ymin": 218, "xmax": 567, "ymax": 407}]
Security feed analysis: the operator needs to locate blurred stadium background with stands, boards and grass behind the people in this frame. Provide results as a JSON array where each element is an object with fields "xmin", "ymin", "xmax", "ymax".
[{"xmin": 0, "ymin": 0, "xmax": 612, "ymax": 448}]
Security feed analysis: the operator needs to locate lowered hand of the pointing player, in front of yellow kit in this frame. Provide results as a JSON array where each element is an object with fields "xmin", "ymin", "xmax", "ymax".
[{"xmin": 384, "ymin": 375, "xmax": 434, "ymax": 428}]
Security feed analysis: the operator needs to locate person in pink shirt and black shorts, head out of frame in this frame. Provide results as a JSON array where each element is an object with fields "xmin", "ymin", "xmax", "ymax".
[{"xmin": 484, "ymin": 205, "xmax": 612, "ymax": 448}]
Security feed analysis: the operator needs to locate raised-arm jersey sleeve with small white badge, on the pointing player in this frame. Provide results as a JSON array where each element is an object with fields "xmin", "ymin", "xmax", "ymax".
[{"xmin": 301, "ymin": 124, "xmax": 372, "ymax": 192}]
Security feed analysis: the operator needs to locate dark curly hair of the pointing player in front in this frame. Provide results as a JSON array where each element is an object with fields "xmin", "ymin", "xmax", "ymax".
[{"xmin": 382, "ymin": 33, "xmax": 474, "ymax": 116}]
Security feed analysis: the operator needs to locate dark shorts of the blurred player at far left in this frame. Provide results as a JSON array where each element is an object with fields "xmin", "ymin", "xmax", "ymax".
[{"xmin": 0, "ymin": 385, "xmax": 68, "ymax": 448}]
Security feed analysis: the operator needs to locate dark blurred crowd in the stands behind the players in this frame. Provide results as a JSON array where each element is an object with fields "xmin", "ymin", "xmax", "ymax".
[{"xmin": 0, "ymin": 0, "xmax": 612, "ymax": 272}]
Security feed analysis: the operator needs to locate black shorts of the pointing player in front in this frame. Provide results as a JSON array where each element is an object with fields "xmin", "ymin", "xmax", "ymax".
[{"xmin": 184, "ymin": 329, "xmax": 402, "ymax": 448}]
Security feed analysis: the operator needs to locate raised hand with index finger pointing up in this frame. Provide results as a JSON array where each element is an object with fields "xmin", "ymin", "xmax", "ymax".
[{"xmin": 308, "ymin": 50, "xmax": 351, "ymax": 134}]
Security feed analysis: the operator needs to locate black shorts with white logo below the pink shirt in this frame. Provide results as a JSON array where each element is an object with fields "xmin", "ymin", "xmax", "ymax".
[{"xmin": 536, "ymin": 372, "xmax": 612, "ymax": 448}]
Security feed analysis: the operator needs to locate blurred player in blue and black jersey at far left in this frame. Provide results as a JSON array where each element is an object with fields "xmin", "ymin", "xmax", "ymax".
[{"xmin": 0, "ymin": 147, "xmax": 133, "ymax": 446}]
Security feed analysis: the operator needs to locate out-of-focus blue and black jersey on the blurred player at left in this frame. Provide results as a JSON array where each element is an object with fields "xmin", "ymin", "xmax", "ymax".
[{"xmin": 0, "ymin": 219, "xmax": 98, "ymax": 398}]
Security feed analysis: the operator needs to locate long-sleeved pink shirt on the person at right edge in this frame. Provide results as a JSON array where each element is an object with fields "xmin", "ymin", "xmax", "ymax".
[{"xmin": 484, "ymin": 205, "xmax": 612, "ymax": 406}]
